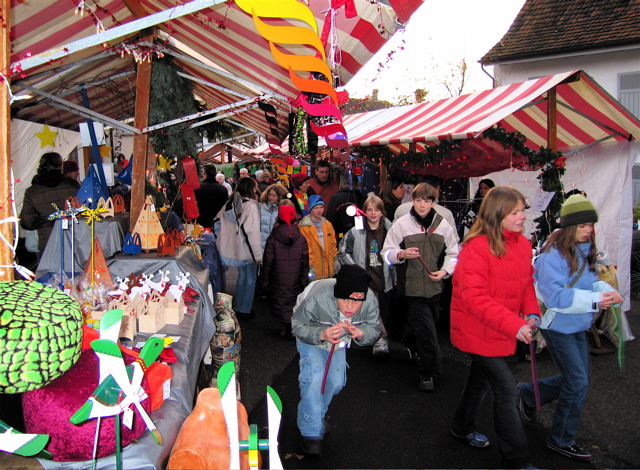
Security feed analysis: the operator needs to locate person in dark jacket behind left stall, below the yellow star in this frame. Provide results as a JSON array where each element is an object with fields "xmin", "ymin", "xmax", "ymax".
[{"xmin": 20, "ymin": 152, "xmax": 80, "ymax": 253}]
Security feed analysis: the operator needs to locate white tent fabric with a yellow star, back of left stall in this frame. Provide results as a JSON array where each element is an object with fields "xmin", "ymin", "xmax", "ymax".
[{"xmin": 11, "ymin": 119, "xmax": 80, "ymax": 216}]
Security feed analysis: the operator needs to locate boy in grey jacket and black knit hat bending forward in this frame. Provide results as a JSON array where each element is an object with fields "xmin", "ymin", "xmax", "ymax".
[{"xmin": 291, "ymin": 265, "xmax": 380, "ymax": 456}]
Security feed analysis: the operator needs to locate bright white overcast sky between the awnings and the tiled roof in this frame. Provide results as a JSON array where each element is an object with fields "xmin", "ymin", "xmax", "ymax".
[{"xmin": 345, "ymin": 0, "xmax": 525, "ymax": 102}]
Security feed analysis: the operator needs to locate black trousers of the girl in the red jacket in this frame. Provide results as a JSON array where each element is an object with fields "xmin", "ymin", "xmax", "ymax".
[{"xmin": 451, "ymin": 354, "xmax": 530, "ymax": 468}]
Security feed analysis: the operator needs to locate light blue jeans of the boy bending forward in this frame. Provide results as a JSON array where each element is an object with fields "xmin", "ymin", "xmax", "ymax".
[{"xmin": 296, "ymin": 340, "xmax": 347, "ymax": 439}]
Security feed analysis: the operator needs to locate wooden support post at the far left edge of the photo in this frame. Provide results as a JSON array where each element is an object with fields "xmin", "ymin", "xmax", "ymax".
[{"xmin": 0, "ymin": 0, "xmax": 13, "ymax": 281}]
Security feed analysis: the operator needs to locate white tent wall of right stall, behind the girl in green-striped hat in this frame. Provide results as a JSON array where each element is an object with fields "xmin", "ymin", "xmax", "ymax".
[{"xmin": 469, "ymin": 141, "xmax": 640, "ymax": 322}]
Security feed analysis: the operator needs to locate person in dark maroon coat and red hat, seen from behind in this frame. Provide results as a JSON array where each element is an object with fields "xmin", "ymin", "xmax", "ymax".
[{"xmin": 262, "ymin": 222, "xmax": 309, "ymax": 323}]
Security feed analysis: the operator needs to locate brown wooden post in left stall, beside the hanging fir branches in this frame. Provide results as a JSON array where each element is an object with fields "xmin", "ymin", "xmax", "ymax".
[{"xmin": 129, "ymin": 29, "xmax": 155, "ymax": 230}]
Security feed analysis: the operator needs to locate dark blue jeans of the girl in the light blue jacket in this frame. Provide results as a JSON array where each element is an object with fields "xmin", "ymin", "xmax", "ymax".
[{"xmin": 520, "ymin": 330, "xmax": 590, "ymax": 447}]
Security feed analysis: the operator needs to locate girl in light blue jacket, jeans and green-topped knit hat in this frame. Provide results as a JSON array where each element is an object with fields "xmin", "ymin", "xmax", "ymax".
[{"xmin": 518, "ymin": 194, "xmax": 622, "ymax": 461}]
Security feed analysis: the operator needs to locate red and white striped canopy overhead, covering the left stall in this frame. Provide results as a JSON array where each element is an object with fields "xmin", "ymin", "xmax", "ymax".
[{"xmin": 10, "ymin": 0, "xmax": 421, "ymax": 139}]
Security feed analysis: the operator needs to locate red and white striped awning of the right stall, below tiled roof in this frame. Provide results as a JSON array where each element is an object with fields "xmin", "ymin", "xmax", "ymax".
[{"xmin": 254, "ymin": 71, "xmax": 640, "ymax": 177}]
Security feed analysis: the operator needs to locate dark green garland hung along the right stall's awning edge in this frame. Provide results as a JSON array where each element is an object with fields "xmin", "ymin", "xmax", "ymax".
[{"xmin": 357, "ymin": 123, "xmax": 566, "ymax": 241}]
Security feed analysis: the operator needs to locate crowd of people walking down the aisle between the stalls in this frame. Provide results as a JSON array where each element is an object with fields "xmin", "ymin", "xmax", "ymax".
[{"xmin": 199, "ymin": 161, "xmax": 622, "ymax": 468}]
